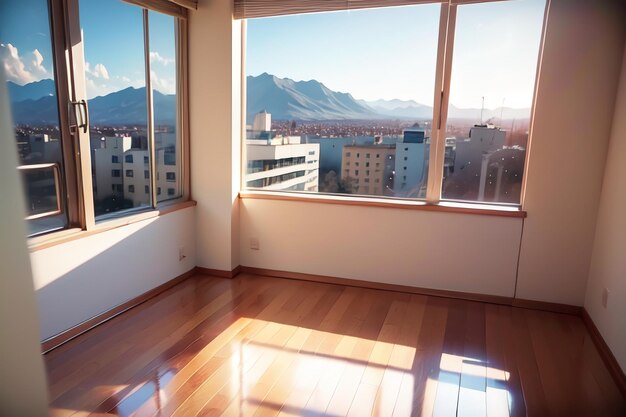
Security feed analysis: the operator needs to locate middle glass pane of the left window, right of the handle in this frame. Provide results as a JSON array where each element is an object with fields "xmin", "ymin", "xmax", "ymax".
[{"xmin": 80, "ymin": 0, "xmax": 151, "ymax": 216}]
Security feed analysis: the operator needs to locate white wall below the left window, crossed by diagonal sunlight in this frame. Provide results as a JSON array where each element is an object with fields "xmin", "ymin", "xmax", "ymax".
[{"xmin": 31, "ymin": 207, "xmax": 196, "ymax": 340}]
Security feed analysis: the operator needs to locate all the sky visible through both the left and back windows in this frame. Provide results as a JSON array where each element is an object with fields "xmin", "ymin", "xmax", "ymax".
[{"xmin": 0, "ymin": 0, "xmax": 545, "ymax": 108}]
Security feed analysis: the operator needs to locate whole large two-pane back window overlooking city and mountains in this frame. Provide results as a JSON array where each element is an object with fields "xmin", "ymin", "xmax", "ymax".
[{"xmin": 241, "ymin": 0, "xmax": 545, "ymax": 205}]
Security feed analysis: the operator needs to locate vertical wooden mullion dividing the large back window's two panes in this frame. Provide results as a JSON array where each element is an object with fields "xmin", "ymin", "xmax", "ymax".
[{"xmin": 426, "ymin": 4, "xmax": 456, "ymax": 204}]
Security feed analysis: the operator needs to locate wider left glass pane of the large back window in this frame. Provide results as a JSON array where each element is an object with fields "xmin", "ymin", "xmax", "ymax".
[{"xmin": 244, "ymin": 4, "xmax": 440, "ymax": 198}]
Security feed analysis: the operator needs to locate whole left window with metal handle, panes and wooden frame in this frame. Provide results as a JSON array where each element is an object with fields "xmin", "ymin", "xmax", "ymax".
[{"xmin": 0, "ymin": 0, "xmax": 186, "ymax": 235}]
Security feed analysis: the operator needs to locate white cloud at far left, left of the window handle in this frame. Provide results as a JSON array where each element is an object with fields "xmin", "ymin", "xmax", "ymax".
[{"xmin": 0, "ymin": 43, "xmax": 52, "ymax": 85}]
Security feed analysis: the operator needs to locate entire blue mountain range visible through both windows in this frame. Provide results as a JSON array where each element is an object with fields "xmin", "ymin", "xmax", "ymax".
[{"xmin": 7, "ymin": 73, "xmax": 530, "ymax": 126}]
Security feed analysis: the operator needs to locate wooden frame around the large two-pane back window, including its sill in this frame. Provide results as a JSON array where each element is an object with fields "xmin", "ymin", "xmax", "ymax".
[{"xmin": 239, "ymin": 0, "xmax": 551, "ymax": 211}]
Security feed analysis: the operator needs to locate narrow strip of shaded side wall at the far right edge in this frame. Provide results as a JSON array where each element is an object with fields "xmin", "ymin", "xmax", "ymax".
[{"xmin": 585, "ymin": 44, "xmax": 626, "ymax": 371}]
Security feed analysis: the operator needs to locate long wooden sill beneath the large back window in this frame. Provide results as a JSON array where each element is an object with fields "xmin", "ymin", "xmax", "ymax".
[{"xmin": 239, "ymin": 191, "xmax": 527, "ymax": 218}]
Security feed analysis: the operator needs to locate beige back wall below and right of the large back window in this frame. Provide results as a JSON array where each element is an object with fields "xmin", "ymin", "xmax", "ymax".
[{"xmin": 235, "ymin": 0, "xmax": 624, "ymax": 305}]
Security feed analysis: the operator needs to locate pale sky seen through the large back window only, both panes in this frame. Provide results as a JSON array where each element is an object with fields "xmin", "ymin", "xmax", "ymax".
[{"xmin": 246, "ymin": 0, "xmax": 545, "ymax": 108}]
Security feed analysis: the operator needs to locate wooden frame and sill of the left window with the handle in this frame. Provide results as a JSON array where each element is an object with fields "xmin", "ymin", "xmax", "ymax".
[{"xmin": 22, "ymin": 0, "xmax": 191, "ymax": 244}]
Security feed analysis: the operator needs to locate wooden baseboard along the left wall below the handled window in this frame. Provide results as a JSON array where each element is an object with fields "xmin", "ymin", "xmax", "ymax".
[{"xmin": 41, "ymin": 268, "xmax": 196, "ymax": 353}]
